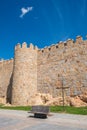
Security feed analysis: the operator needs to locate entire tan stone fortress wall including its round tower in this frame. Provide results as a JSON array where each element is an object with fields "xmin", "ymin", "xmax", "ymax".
[{"xmin": 0, "ymin": 36, "xmax": 87, "ymax": 105}]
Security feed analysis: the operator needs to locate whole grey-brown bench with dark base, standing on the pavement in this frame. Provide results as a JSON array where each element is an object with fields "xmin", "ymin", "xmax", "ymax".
[{"xmin": 30, "ymin": 105, "xmax": 50, "ymax": 118}]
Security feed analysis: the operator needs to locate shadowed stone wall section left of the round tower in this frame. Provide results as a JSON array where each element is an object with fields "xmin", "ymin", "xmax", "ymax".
[{"xmin": 0, "ymin": 59, "xmax": 13, "ymax": 103}]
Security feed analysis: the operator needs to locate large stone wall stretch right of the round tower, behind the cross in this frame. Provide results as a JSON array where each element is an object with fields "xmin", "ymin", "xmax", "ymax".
[{"xmin": 37, "ymin": 36, "xmax": 87, "ymax": 97}]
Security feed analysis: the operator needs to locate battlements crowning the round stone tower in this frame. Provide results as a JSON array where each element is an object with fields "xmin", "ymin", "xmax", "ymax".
[{"xmin": 15, "ymin": 42, "xmax": 38, "ymax": 50}]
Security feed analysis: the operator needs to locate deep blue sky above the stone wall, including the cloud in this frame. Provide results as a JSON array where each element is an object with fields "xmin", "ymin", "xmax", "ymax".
[{"xmin": 0, "ymin": 0, "xmax": 87, "ymax": 59}]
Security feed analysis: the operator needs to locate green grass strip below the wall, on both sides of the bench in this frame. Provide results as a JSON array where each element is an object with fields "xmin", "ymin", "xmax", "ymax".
[{"xmin": 0, "ymin": 105, "xmax": 87, "ymax": 115}]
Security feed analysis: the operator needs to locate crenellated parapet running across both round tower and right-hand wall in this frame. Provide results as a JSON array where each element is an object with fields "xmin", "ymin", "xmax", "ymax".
[{"xmin": 15, "ymin": 36, "xmax": 84, "ymax": 53}]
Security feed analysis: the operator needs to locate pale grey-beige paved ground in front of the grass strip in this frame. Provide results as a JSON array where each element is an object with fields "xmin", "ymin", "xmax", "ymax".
[{"xmin": 0, "ymin": 109, "xmax": 87, "ymax": 130}]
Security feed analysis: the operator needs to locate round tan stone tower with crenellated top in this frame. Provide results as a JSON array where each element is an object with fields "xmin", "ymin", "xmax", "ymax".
[{"xmin": 12, "ymin": 42, "xmax": 37, "ymax": 105}]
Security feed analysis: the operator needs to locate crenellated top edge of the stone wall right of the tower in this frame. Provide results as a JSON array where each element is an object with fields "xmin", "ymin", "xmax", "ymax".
[{"xmin": 39, "ymin": 36, "xmax": 85, "ymax": 53}]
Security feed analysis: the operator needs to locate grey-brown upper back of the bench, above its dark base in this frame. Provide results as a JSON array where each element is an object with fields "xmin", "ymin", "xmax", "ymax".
[{"xmin": 31, "ymin": 105, "xmax": 49, "ymax": 113}]
